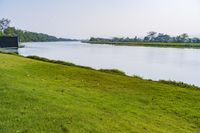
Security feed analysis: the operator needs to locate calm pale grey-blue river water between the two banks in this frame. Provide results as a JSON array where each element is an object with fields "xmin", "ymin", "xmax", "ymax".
[{"xmin": 18, "ymin": 42, "xmax": 200, "ymax": 86}]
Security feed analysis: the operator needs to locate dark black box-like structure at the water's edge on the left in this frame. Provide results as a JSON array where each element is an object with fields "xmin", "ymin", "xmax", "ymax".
[{"xmin": 0, "ymin": 36, "xmax": 19, "ymax": 48}]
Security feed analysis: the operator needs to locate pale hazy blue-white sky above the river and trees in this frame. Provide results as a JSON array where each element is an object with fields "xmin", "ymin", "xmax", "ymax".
[{"xmin": 0, "ymin": 0, "xmax": 200, "ymax": 39}]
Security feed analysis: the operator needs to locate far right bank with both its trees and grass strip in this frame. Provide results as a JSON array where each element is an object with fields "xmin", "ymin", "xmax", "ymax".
[{"xmin": 83, "ymin": 32, "xmax": 200, "ymax": 48}]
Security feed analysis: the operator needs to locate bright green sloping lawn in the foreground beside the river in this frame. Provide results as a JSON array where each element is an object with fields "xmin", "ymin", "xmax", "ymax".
[{"xmin": 0, "ymin": 53, "xmax": 200, "ymax": 133}]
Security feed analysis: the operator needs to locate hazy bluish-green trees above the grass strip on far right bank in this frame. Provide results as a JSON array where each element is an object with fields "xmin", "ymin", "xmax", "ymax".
[{"xmin": 89, "ymin": 31, "xmax": 200, "ymax": 43}]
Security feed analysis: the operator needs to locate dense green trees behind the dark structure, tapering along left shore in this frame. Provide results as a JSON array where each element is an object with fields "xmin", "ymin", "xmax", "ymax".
[{"xmin": 0, "ymin": 18, "xmax": 76, "ymax": 42}]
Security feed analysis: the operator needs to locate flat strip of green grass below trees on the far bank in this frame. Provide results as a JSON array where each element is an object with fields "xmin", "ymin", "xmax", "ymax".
[{"xmin": 83, "ymin": 41, "xmax": 200, "ymax": 48}]
